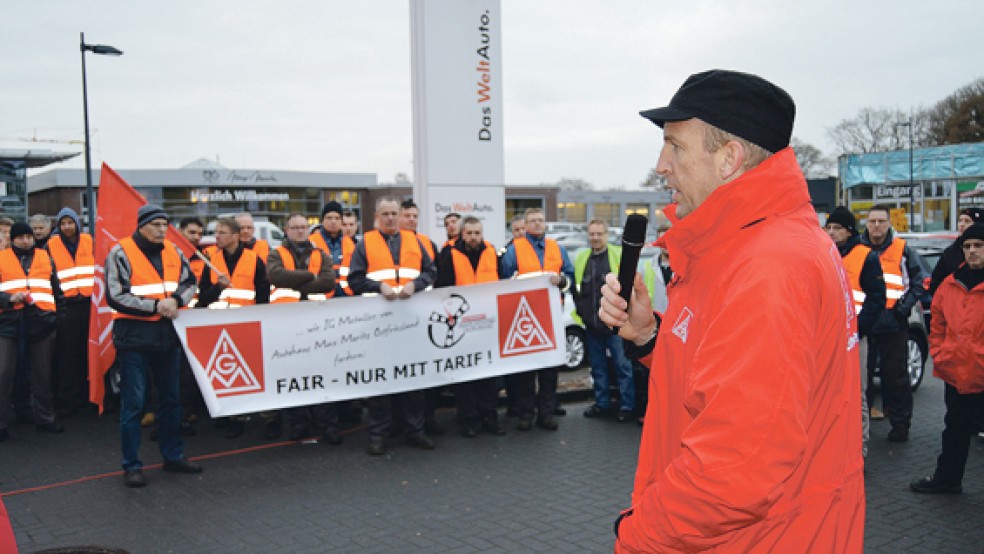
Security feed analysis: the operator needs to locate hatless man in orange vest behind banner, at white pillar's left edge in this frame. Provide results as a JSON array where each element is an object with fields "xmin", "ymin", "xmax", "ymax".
[{"xmin": 349, "ymin": 196, "xmax": 436, "ymax": 456}]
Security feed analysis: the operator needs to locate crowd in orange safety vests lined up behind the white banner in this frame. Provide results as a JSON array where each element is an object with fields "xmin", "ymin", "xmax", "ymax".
[{"xmin": 0, "ymin": 197, "xmax": 632, "ymax": 487}]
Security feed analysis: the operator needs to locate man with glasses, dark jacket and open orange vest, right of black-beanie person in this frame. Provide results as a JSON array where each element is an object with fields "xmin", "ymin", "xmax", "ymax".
[{"xmin": 861, "ymin": 205, "xmax": 924, "ymax": 442}]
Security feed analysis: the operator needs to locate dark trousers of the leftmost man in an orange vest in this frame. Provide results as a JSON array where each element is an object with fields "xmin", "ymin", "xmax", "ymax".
[{"xmin": 0, "ymin": 333, "xmax": 55, "ymax": 429}]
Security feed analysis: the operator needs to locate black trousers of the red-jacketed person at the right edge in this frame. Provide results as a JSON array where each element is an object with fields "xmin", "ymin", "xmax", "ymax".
[{"xmin": 936, "ymin": 384, "xmax": 984, "ymax": 485}]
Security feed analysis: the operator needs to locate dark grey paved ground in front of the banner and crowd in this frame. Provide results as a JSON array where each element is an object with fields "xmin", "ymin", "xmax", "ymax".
[{"xmin": 0, "ymin": 364, "xmax": 984, "ymax": 553}]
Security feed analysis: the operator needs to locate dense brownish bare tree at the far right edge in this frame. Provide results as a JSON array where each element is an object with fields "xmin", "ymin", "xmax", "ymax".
[{"xmin": 927, "ymin": 77, "xmax": 984, "ymax": 144}]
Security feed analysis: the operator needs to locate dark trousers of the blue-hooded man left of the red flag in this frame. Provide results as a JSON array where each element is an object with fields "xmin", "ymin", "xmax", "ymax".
[{"xmin": 55, "ymin": 300, "xmax": 90, "ymax": 411}]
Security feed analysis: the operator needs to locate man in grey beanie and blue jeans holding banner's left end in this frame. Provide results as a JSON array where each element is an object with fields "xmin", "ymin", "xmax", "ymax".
[{"xmin": 105, "ymin": 204, "xmax": 202, "ymax": 487}]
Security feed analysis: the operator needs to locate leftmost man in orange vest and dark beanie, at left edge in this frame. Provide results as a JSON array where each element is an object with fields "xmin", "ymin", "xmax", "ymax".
[{"xmin": 0, "ymin": 222, "xmax": 65, "ymax": 441}]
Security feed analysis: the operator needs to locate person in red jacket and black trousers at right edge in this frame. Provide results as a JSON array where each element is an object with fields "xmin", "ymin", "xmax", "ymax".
[{"xmin": 909, "ymin": 223, "xmax": 984, "ymax": 494}]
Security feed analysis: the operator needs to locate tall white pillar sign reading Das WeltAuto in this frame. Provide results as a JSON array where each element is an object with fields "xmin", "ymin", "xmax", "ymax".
[{"xmin": 410, "ymin": 0, "xmax": 506, "ymax": 246}]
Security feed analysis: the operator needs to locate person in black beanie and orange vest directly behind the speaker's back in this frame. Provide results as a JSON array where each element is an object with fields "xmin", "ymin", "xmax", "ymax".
[{"xmin": 824, "ymin": 206, "xmax": 885, "ymax": 456}]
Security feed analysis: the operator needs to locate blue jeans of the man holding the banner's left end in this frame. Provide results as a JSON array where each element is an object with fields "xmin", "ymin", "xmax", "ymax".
[{"xmin": 116, "ymin": 348, "xmax": 184, "ymax": 470}]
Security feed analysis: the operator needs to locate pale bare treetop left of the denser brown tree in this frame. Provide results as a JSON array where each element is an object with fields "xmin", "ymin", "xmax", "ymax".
[{"xmin": 827, "ymin": 108, "xmax": 931, "ymax": 154}]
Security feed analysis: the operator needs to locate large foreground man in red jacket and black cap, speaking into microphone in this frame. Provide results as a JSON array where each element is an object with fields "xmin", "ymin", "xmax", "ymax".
[{"xmin": 600, "ymin": 70, "xmax": 865, "ymax": 553}]
